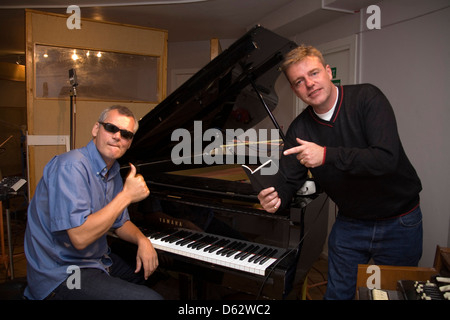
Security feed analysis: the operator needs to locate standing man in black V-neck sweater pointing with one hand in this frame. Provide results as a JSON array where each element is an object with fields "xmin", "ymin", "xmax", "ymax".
[{"xmin": 258, "ymin": 46, "xmax": 422, "ymax": 299}]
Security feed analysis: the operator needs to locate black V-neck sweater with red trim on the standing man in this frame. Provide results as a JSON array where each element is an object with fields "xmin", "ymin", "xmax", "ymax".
[{"xmin": 277, "ymin": 84, "xmax": 422, "ymax": 220}]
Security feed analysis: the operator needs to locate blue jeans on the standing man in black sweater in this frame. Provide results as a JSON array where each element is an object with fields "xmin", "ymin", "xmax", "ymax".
[{"xmin": 324, "ymin": 207, "xmax": 422, "ymax": 300}]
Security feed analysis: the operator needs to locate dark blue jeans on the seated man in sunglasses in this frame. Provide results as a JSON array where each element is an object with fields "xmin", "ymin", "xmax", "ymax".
[{"xmin": 48, "ymin": 253, "xmax": 163, "ymax": 300}]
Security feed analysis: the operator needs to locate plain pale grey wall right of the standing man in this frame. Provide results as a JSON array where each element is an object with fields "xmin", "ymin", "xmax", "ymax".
[{"xmin": 361, "ymin": 1, "xmax": 450, "ymax": 266}]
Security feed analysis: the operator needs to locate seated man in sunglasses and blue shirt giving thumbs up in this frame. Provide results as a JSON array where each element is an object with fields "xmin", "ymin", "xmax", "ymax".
[{"xmin": 24, "ymin": 106, "xmax": 162, "ymax": 300}]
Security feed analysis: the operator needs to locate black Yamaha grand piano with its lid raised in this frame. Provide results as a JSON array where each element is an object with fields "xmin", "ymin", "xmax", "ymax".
[{"xmin": 120, "ymin": 26, "xmax": 328, "ymax": 299}]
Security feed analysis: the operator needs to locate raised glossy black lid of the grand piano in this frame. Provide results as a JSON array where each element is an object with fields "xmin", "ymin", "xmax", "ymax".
[{"xmin": 119, "ymin": 26, "xmax": 296, "ymax": 166}]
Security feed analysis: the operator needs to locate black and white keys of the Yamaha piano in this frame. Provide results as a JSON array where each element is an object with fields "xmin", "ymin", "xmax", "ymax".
[{"xmin": 147, "ymin": 229, "xmax": 285, "ymax": 275}]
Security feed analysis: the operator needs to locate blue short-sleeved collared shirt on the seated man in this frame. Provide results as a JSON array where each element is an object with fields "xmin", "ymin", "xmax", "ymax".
[{"xmin": 24, "ymin": 141, "xmax": 129, "ymax": 299}]
